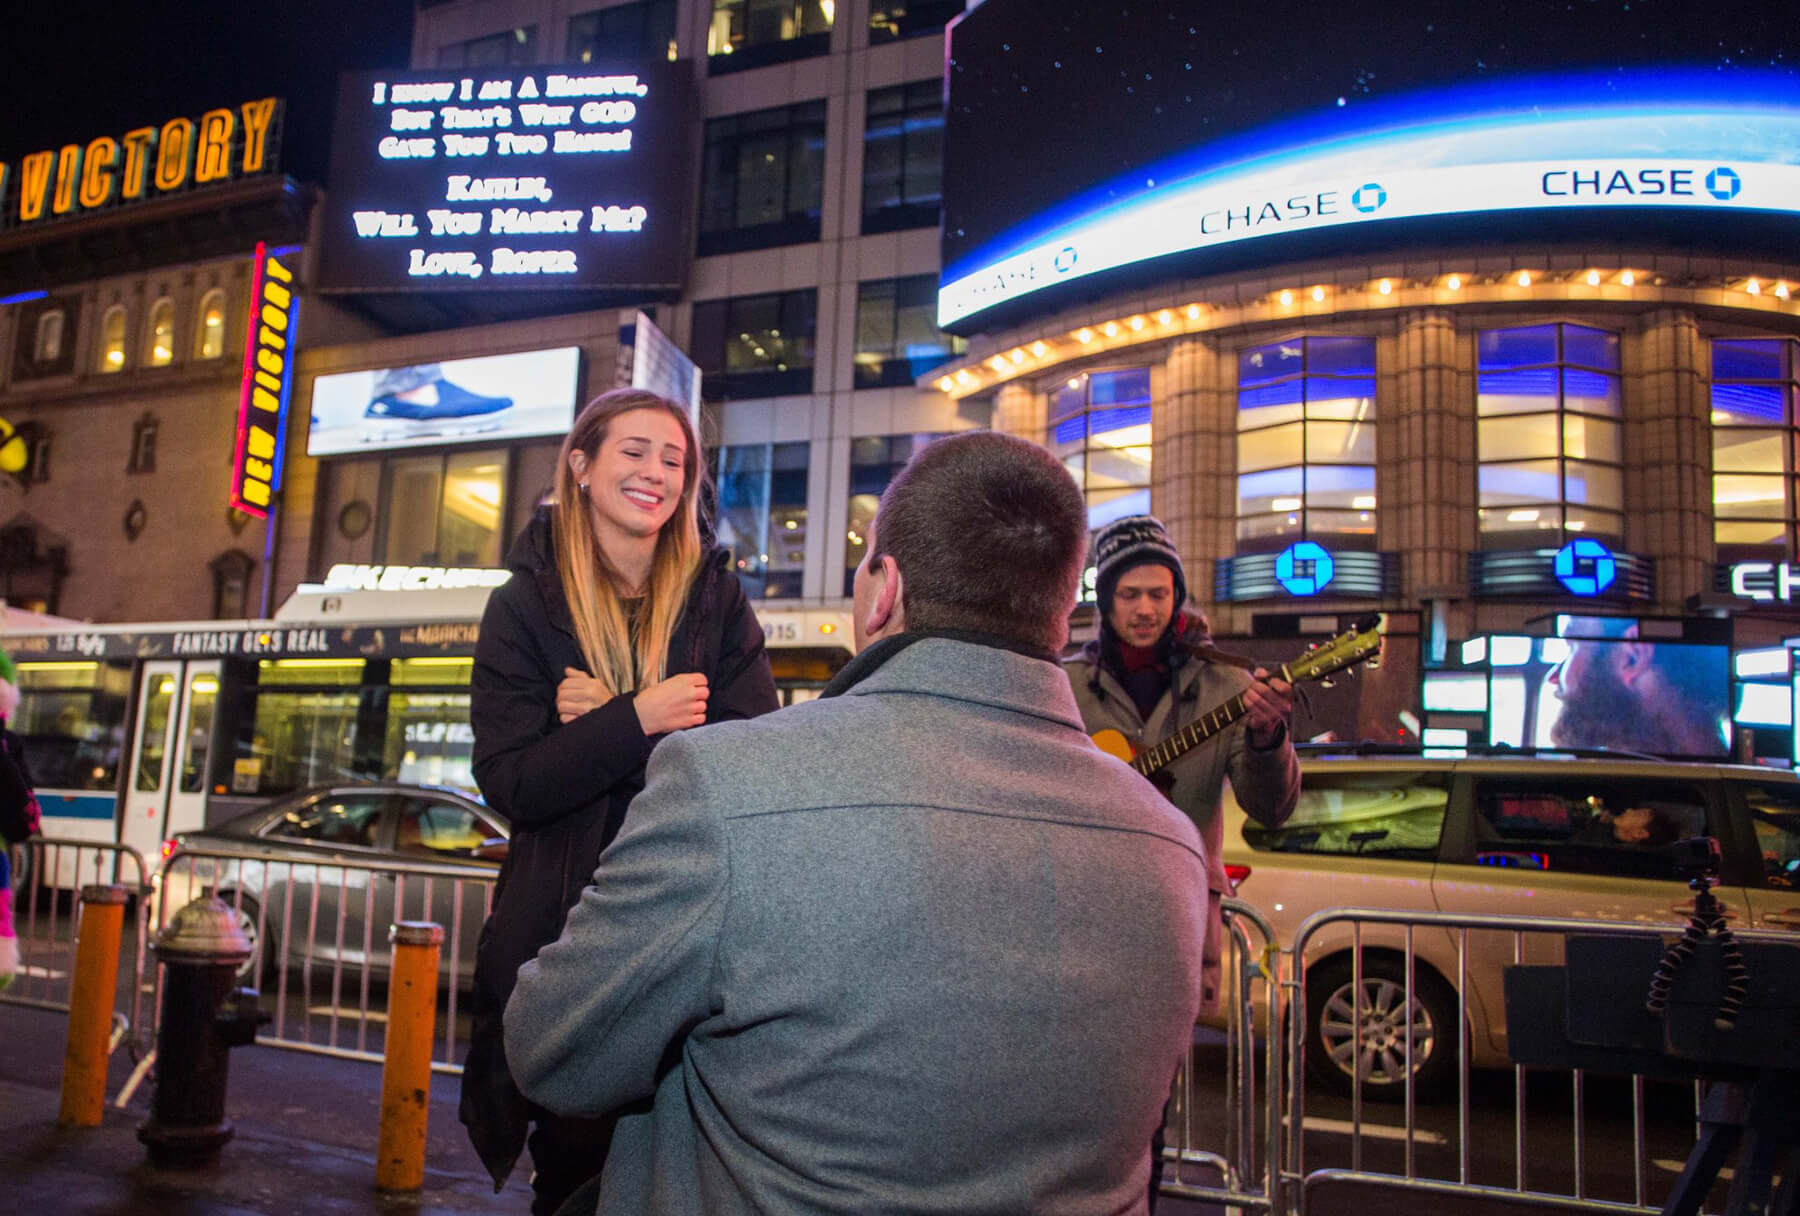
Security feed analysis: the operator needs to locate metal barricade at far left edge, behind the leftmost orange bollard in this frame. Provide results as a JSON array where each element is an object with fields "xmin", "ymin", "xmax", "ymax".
[{"xmin": 0, "ymin": 836, "xmax": 151, "ymax": 1056}]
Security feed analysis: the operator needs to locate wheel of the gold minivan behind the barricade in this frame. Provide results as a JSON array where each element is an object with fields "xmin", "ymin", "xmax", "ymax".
[{"xmin": 1307, "ymin": 953, "xmax": 1456, "ymax": 1103}]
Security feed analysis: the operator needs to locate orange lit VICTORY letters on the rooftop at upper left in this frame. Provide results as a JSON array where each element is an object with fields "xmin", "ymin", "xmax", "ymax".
[{"xmin": 0, "ymin": 97, "xmax": 281, "ymax": 225}]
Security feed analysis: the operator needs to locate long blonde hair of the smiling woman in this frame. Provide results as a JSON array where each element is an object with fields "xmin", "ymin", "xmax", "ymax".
[{"xmin": 551, "ymin": 389, "xmax": 706, "ymax": 696}]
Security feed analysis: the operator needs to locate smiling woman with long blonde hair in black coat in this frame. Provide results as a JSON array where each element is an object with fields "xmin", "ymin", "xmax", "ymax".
[{"xmin": 461, "ymin": 389, "xmax": 776, "ymax": 1216}]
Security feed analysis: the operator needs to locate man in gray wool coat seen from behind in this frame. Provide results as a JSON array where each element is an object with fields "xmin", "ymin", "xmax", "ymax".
[{"xmin": 506, "ymin": 432, "xmax": 1208, "ymax": 1216}]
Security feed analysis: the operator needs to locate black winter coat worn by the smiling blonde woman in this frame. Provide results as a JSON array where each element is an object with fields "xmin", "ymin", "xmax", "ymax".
[{"xmin": 461, "ymin": 509, "xmax": 778, "ymax": 1184}]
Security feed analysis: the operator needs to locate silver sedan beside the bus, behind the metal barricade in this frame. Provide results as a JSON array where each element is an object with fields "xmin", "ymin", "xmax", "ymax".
[{"xmin": 151, "ymin": 782, "xmax": 508, "ymax": 986}]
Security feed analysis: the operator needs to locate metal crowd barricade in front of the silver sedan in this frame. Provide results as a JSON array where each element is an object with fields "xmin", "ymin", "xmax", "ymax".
[{"xmin": 148, "ymin": 847, "xmax": 495, "ymax": 1074}]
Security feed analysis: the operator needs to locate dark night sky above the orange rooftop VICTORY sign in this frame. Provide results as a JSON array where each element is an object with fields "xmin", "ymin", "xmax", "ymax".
[{"xmin": 0, "ymin": 0, "xmax": 412, "ymax": 182}]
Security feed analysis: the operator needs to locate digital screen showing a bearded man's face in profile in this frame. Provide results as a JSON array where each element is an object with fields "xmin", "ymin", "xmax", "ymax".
[{"xmin": 1530, "ymin": 617, "xmax": 1732, "ymax": 757}]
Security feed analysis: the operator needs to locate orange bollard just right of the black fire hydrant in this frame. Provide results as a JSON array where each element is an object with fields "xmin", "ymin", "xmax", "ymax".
[{"xmin": 374, "ymin": 921, "xmax": 445, "ymax": 1191}]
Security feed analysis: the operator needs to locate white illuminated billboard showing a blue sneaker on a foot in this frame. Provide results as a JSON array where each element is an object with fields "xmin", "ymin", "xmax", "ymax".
[{"xmin": 306, "ymin": 345, "xmax": 581, "ymax": 457}]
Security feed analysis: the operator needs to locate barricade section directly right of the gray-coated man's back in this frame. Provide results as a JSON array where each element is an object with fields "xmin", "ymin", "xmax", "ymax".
[{"xmin": 1161, "ymin": 899, "xmax": 1283, "ymax": 1214}]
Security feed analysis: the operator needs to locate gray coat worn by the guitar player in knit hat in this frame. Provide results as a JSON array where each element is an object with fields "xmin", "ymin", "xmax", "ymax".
[{"xmin": 1064, "ymin": 640, "xmax": 1300, "ymax": 1013}]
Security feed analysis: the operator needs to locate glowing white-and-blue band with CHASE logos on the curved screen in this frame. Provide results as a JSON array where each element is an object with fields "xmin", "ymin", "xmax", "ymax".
[{"xmin": 938, "ymin": 79, "xmax": 1800, "ymax": 326}]
